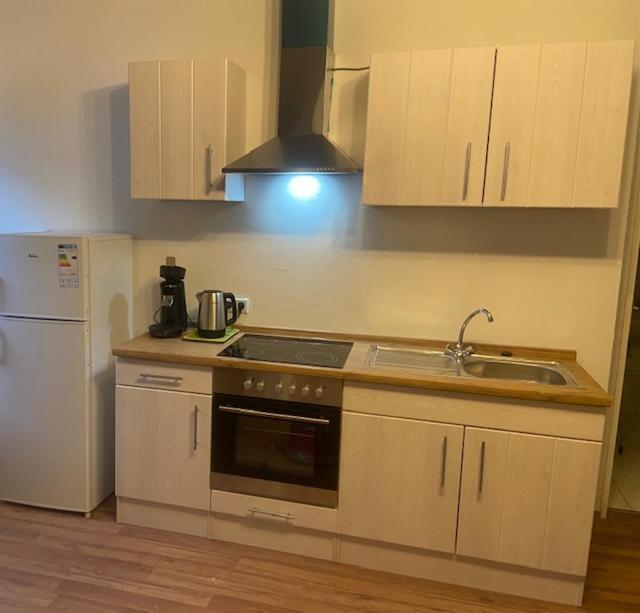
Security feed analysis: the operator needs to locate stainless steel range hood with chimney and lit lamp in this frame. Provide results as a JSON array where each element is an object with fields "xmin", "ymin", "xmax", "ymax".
[{"xmin": 222, "ymin": 0, "xmax": 362, "ymax": 181}]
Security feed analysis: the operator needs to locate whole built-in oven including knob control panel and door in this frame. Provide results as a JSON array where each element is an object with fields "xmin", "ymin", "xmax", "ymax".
[{"xmin": 211, "ymin": 370, "xmax": 342, "ymax": 507}]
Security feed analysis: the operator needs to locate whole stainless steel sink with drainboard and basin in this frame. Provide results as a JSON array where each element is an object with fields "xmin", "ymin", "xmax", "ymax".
[{"xmin": 364, "ymin": 345, "xmax": 578, "ymax": 387}]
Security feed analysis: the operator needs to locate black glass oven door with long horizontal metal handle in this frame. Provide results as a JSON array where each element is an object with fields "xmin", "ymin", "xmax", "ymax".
[{"xmin": 211, "ymin": 394, "xmax": 340, "ymax": 507}]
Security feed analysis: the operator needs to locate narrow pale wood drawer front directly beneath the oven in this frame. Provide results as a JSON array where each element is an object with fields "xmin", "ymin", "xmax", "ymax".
[{"xmin": 211, "ymin": 490, "xmax": 337, "ymax": 533}]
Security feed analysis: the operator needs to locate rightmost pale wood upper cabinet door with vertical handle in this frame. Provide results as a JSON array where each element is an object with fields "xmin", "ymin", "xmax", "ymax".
[{"xmin": 484, "ymin": 41, "xmax": 634, "ymax": 207}]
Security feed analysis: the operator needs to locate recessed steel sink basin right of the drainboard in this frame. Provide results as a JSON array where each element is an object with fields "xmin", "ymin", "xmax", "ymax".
[{"xmin": 462, "ymin": 357, "xmax": 575, "ymax": 385}]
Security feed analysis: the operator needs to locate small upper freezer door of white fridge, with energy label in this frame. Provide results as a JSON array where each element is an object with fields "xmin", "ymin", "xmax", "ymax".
[{"xmin": 0, "ymin": 234, "xmax": 89, "ymax": 320}]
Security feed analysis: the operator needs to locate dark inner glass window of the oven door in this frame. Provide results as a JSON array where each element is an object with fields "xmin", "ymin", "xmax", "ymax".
[{"xmin": 234, "ymin": 417, "xmax": 317, "ymax": 481}]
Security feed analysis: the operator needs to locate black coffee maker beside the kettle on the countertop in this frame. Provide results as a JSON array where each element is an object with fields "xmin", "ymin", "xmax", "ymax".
[{"xmin": 149, "ymin": 257, "xmax": 189, "ymax": 338}]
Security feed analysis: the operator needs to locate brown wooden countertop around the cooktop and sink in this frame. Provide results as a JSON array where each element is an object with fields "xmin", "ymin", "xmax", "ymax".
[{"xmin": 113, "ymin": 326, "xmax": 611, "ymax": 408}]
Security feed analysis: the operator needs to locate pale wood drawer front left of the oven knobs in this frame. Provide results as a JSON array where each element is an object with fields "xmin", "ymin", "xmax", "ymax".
[{"xmin": 116, "ymin": 358, "xmax": 213, "ymax": 394}]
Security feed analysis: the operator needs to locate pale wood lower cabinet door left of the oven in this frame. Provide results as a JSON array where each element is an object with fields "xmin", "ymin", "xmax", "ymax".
[{"xmin": 116, "ymin": 386, "xmax": 211, "ymax": 510}]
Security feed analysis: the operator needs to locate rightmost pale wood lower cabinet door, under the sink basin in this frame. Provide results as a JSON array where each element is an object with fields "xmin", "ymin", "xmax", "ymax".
[{"xmin": 456, "ymin": 428, "xmax": 601, "ymax": 576}]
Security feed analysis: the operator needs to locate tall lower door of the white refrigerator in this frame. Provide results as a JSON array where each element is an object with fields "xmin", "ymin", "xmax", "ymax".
[{"xmin": 0, "ymin": 317, "xmax": 90, "ymax": 512}]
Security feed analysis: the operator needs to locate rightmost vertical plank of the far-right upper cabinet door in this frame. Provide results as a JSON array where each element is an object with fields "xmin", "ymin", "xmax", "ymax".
[{"xmin": 573, "ymin": 40, "xmax": 634, "ymax": 207}]
